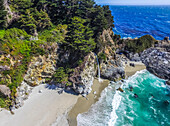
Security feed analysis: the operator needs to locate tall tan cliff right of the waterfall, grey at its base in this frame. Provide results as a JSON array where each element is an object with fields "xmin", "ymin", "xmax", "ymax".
[{"xmin": 99, "ymin": 30, "xmax": 125, "ymax": 81}]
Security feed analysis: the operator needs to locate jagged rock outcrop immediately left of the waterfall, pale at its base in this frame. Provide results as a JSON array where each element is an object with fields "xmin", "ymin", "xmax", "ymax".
[{"xmin": 69, "ymin": 52, "xmax": 97, "ymax": 94}]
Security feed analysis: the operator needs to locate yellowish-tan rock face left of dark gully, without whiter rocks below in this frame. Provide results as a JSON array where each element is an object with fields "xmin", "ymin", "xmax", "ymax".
[{"xmin": 24, "ymin": 54, "xmax": 58, "ymax": 86}]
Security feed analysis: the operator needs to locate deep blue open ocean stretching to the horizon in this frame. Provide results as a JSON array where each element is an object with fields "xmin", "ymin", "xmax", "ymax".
[{"xmin": 110, "ymin": 6, "xmax": 170, "ymax": 40}]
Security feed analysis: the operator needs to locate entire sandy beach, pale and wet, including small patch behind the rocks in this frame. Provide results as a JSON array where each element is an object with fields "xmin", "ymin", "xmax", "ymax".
[{"xmin": 0, "ymin": 61, "xmax": 146, "ymax": 126}]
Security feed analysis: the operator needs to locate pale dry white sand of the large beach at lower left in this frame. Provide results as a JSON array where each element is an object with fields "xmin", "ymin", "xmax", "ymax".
[{"xmin": 0, "ymin": 85, "xmax": 78, "ymax": 126}]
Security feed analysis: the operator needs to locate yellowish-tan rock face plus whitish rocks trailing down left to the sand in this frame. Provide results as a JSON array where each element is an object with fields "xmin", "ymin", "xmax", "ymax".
[{"xmin": 13, "ymin": 45, "xmax": 58, "ymax": 109}]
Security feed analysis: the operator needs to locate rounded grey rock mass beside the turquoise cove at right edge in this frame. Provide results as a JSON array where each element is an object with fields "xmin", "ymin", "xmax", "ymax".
[{"xmin": 141, "ymin": 48, "xmax": 170, "ymax": 81}]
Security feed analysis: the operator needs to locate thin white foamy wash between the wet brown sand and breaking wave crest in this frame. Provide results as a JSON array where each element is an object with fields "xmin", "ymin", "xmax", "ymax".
[{"xmin": 77, "ymin": 86, "xmax": 113, "ymax": 126}]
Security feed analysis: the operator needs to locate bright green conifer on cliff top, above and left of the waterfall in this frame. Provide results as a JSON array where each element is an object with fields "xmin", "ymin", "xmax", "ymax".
[{"xmin": 66, "ymin": 17, "xmax": 96, "ymax": 54}]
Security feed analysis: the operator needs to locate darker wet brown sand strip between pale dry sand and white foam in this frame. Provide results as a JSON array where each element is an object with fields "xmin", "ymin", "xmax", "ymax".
[{"xmin": 68, "ymin": 79, "xmax": 109, "ymax": 126}]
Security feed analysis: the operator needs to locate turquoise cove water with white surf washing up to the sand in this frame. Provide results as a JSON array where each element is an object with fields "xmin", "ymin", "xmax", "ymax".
[{"xmin": 77, "ymin": 70, "xmax": 170, "ymax": 126}]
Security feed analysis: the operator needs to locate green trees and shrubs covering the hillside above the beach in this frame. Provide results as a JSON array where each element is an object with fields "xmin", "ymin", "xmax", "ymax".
[{"xmin": 0, "ymin": 0, "xmax": 114, "ymax": 108}]
